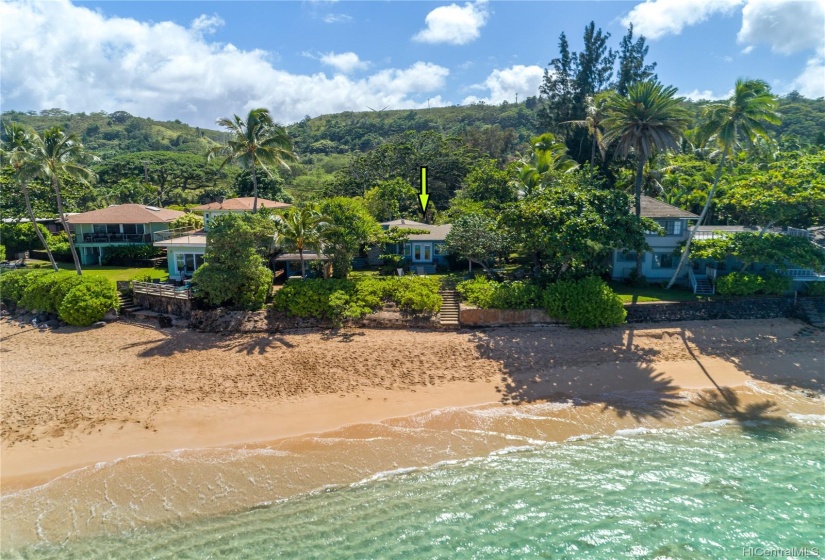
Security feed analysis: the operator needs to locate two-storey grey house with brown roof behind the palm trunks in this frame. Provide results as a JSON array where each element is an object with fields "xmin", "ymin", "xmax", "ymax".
[{"xmin": 611, "ymin": 196, "xmax": 699, "ymax": 281}]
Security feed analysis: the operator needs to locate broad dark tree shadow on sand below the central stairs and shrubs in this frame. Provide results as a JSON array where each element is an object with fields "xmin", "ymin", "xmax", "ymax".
[{"xmin": 471, "ymin": 327, "xmax": 686, "ymax": 421}]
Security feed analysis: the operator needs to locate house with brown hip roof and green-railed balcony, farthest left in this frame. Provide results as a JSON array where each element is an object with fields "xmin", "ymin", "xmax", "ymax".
[{"xmin": 66, "ymin": 204, "xmax": 184, "ymax": 265}]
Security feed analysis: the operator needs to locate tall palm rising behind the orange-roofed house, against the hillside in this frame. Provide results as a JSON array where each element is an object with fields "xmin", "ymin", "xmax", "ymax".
[{"xmin": 207, "ymin": 109, "xmax": 298, "ymax": 212}]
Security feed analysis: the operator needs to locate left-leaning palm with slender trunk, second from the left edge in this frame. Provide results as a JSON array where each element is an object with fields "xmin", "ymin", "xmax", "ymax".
[{"xmin": 20, "ymin": 126, "xmax": 95, "ymax": 275}]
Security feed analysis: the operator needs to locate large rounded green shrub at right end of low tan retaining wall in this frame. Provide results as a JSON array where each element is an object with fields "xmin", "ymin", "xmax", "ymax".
[{"xmin": 544, "ymin": 276, "xmax": 627, "ymax": 329}]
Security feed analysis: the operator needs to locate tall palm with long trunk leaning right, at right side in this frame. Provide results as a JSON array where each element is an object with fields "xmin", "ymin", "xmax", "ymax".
[{"xmin": 667, "ymin": 78, "xmax": 781, "ymax": 288}]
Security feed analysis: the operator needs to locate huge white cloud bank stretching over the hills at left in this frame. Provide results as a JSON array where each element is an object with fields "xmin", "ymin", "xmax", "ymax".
[{"xmin": 0, "ymin": 0, "xmax": 449, "ymax": 127}]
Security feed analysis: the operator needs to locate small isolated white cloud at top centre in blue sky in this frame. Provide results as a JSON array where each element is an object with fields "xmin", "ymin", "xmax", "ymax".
[{"xmin": 413, "ymin": 0, "xmax": 489, "ymax": 45}]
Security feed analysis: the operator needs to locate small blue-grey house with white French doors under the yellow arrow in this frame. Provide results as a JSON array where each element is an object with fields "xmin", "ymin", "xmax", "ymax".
[{"xmin": 367, "ymin": 219, "xmax": 453, "ymax": 274}]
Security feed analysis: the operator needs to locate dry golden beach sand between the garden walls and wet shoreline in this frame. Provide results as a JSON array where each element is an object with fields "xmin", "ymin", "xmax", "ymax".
[{"xmin": 0, "ymin": 319, "xmax": 825, "ymax": 492}]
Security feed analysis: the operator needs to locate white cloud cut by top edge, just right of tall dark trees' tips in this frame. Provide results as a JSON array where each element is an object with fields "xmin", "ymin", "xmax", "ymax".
[{"xmin": 622, "ymin": 0, "xmax": 744, "ymax": 40}]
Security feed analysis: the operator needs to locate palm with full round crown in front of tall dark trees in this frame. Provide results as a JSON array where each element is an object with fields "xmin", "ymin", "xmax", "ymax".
[{"xmin": 603, "ymin": 80, "xmax": 689, "ymax": 276}]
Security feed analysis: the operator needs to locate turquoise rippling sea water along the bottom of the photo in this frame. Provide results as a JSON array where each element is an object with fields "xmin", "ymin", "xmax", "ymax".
[{"xmin": 4, "ymin": 415, "xmax": 825, "ymax": 560}]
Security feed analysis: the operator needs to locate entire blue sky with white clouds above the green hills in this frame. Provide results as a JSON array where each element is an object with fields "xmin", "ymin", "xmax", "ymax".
[{"xmin": 0, "ymin": 0, "xmax": 825, "ymax": 128}]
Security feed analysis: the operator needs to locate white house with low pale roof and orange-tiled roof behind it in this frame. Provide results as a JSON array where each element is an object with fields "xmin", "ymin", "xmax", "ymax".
[{"xmin": 155, "ymin": 196, "xmax": 291, "ymax": 280}]
